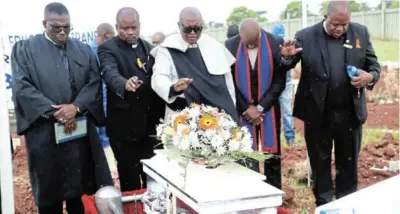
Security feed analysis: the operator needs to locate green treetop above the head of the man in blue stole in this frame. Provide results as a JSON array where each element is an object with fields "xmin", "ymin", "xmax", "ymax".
[{"xmin": 226, "ymin": 6, "xmax": 267, "ymax": 25}]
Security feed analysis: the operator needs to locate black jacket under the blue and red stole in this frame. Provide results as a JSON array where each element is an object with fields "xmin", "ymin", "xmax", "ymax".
[{"xmin": 225, "ymin": 32, "xmax": 289, "ymax": 115}]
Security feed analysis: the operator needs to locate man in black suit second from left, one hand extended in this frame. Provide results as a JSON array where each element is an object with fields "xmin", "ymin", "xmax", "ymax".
[{"xmin": 98, "ymin": 8, "xmax": 165, "ymax": 191}]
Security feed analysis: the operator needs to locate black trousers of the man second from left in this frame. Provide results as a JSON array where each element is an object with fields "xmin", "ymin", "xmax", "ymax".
[{"xmin": 110, "ymin": 137, "xmax": 158, "ymax": 192}]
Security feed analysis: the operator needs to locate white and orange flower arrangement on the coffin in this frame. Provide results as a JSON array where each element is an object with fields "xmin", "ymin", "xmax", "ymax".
[{"xmin": 157, "ymin": 104, "xmax": 267, "ymax": 164}]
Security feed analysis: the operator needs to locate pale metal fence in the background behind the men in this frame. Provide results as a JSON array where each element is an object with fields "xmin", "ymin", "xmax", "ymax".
[{"xmin": 204, "ymin": 9, "xmax": 400, "ymax": 42}]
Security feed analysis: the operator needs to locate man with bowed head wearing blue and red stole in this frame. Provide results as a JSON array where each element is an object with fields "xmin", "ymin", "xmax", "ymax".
[{"xmin": 225, "ymin": 19, "xmax": 289, "ymax": 189}]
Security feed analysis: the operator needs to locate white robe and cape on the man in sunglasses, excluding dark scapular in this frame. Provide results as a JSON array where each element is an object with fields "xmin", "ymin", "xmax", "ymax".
[{"xmin": 150, "ymin": 34, "xmax": 236, "ymax": 120}]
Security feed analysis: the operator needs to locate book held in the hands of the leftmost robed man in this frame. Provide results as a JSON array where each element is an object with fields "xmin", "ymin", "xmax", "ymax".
[{"xmin": 54, "ymin": 117, "xmax": 87, "ymax": 144}]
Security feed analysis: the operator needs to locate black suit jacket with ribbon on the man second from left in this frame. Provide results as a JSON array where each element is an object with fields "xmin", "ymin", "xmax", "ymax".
[{"xmin": 98, "ymin": 36, "xmax": 165, "ymax": 141}]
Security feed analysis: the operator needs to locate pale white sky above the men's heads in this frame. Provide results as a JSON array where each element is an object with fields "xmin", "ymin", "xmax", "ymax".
[{"xmin": 0, "ymin": 0, "xmax": 380, "ymax": 36}]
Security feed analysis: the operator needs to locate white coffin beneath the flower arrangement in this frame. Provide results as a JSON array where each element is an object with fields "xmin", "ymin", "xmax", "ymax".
[{"xmin": 142, "ymin": 150, "xmax": 284, "ymax": 214}]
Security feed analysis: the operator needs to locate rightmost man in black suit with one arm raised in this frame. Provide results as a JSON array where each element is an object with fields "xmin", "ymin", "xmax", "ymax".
[{"xmin": 281, "ymin": 1, "xmax": 380, "ymax": 206}]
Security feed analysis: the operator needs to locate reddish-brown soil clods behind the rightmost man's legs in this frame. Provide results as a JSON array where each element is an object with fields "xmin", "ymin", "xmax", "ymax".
[{"xmin": 282, "ymin": 133, "xmax": 399, "ymax": 213}]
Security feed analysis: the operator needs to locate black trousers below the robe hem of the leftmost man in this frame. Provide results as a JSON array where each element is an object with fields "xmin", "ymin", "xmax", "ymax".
[{"xmin": 39, "ymin": 198, "xmax": 85, "ymax": 214}]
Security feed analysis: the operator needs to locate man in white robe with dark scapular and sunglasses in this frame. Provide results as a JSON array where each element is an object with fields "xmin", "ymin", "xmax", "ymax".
[{"xmin": 151, "ymin": 7, "xmax": 239, "ymax": 121}]
